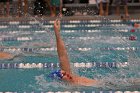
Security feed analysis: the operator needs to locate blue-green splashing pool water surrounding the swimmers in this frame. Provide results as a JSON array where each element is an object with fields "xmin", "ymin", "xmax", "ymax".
[{"xmin": 0, "ymin": 16, "xmax": 140, "ymax": 93}]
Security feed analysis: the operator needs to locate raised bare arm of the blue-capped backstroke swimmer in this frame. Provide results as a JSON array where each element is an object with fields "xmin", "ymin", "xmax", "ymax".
[{"xmin": 54, "ymin": 20, "xmax": 71, "ymax": 73}]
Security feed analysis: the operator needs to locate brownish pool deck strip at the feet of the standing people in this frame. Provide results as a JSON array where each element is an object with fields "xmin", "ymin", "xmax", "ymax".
[{"xmin": 0, "ymin": 14, "xmax": 140, "ymax": 21}]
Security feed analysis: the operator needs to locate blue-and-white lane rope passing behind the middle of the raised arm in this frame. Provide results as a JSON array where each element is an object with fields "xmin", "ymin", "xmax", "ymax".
[{"xmin": 0, "ymin": 47, "xmax": 139, "ymax": 53}]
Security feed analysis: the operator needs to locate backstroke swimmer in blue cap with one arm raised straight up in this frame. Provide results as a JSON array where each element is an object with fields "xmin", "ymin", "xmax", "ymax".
[{"xmin": 50, "ymin": 20, "xmax": 99, "ymax": 86}]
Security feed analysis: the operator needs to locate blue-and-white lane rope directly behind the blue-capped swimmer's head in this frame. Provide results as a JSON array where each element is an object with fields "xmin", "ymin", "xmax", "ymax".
[{"xmin": 0, "ymin": 62, "xmax": 129, "ymax": 69}]
